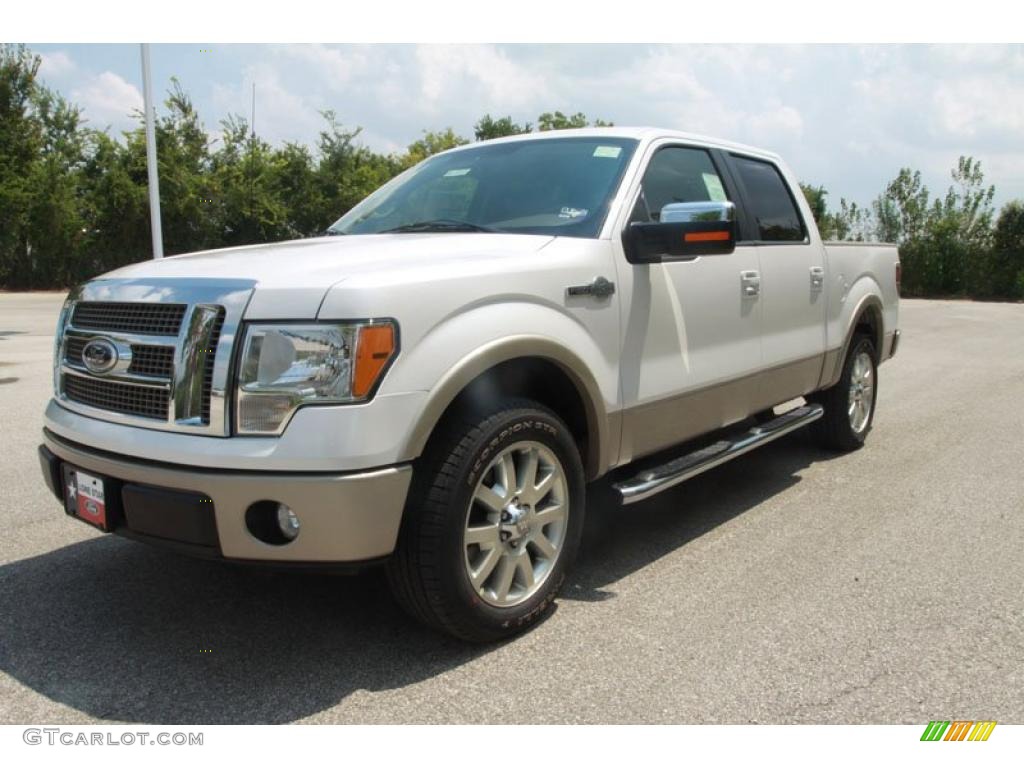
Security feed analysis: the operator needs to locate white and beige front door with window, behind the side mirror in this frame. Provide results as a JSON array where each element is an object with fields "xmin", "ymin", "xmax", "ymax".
[{"xmin": 618, "ymin": 144, "xmax": 762, "ymax": 462}]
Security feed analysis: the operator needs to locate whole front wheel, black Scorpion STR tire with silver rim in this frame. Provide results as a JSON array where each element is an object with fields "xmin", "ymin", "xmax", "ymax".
[{"xmin": 388, "ymin": 399, "xmax": 585, "ymax": 642}]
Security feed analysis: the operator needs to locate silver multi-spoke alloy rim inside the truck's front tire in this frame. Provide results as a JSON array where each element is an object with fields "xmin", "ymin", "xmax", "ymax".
[{"xmin": 463, "ymin": 441, "xmax": 569, "ymax": 608}]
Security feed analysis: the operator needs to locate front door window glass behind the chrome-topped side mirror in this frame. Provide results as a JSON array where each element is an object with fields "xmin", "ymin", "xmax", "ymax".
[{"xmin": 630, "ymin": 146, "xmax": 730, "ymax": 222}]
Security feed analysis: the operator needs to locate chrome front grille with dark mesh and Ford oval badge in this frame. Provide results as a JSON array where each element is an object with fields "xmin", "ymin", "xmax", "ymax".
[{"xmin": 54, "ymin": 279, "xmax": 253, "ymax": 435}]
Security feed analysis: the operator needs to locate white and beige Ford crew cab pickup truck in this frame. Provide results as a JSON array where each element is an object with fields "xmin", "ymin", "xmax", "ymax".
[{"xmin": 40, "ymin": 128, "xmax": 899, "ymax": 641}]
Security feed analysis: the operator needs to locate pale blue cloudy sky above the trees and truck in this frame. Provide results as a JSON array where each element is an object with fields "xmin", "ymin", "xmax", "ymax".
[{"xmin": 30, "ymin": 43, "xmax": 1024, "ymax": 214}]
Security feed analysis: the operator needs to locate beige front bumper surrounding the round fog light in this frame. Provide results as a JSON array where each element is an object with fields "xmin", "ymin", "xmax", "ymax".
[{"xmin": 44, "ymin": 433, "xmax": 413, "ymax": 563}]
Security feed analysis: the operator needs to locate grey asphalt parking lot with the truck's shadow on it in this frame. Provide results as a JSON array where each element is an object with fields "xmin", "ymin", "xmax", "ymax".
[{"xmin": 0, "ymin": 294, "xmax": 1024, "ymax": 724}]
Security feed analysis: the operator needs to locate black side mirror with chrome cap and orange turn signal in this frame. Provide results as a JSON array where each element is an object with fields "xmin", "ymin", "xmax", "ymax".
[{"xmin": 623, "ymin": 201, "xmax": 736, "ymax": 264}]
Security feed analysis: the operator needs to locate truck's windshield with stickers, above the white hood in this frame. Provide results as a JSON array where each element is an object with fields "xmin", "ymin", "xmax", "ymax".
[{"xmin": 328, "ymin": 137, "xmax": 637, "ymax": 238}]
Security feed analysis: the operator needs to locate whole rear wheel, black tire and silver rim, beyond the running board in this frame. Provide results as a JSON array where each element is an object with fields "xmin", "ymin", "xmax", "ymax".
[{"xmin": 807, "ymin": 336, "xmax": 879, "ymax": 452}]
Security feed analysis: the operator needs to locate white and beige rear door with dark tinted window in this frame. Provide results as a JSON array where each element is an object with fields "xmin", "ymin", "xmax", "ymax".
[{"xmin": 729, "ymin": 154, "xmax": 825, "ymax": 407}]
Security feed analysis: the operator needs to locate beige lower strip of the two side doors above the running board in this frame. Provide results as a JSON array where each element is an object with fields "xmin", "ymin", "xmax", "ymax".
[{"xmin": 620, "ymin": 355, "xmax": 822, "ymax": 464}]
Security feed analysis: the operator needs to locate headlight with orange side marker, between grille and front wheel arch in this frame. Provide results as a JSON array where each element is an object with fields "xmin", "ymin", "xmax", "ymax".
[{"xmin": 238, "ymin": 322, "xmax": 396, "ymax": 434}]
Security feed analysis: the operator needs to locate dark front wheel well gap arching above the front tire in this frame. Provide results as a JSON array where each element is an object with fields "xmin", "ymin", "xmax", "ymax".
[{"xmin": 438, "ymin": 357, "xmax": 598, "ymax": 477}]
